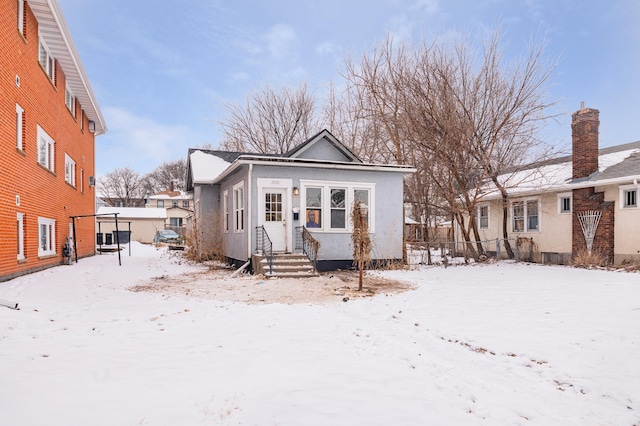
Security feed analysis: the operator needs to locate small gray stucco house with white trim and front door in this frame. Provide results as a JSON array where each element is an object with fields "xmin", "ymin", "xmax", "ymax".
[{"xmin": 186, "ymin": 130, "xmax": 415, "ymax": 271}]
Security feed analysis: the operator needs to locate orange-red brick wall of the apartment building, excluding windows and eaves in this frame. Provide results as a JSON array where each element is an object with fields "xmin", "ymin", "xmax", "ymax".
[{"xmin": 0, "ymin": 1, "xmax": 95, "ymax": 280}]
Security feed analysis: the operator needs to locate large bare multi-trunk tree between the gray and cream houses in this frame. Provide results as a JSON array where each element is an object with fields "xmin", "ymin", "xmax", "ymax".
[{"xmin": 345, "ymin": 30, "xmax": 552, "ymax": 254}]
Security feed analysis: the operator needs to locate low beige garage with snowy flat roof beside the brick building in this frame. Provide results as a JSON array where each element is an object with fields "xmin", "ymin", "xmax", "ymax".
[{"xmin": 96, "ymin": 207, "xmax": 167, "ymax": 244}]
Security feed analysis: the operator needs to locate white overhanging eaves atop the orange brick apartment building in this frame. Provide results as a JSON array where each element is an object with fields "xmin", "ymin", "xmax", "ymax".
[{"xmin": 28, "ymin": 0, "xmax": 107, "ymax": 136}]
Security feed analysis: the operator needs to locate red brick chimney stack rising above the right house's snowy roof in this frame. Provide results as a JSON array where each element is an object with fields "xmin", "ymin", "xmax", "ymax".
[{"xmin": 571, "ymin": 107, "xmax": 600, "ymax": 179}]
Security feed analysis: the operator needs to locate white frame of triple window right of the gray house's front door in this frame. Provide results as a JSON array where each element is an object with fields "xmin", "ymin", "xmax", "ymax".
[{"xmin": 300, "ymin": 180, "xmax": 376, "ymax": 233}]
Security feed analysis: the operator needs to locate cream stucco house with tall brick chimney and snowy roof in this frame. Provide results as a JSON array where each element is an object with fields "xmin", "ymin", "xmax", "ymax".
[{"xmin": 464, "ymin": 108, "xmax": 640, "ymax": 264}]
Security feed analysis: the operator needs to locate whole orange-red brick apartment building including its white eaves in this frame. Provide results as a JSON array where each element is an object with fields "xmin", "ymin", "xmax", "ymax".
[{"xmin": 0, "ymin": 0, "xmax": 106, "ymax": 281}]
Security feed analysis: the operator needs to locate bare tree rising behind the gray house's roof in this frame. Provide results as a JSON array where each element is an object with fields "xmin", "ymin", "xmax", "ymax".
[{"xmin": 219, "ymin": 84, "xmax": 319, "ymax": 154}]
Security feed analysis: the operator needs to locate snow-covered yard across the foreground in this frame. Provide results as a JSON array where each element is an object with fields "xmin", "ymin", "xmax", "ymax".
[{"xmin": 0, "ymin": 243, "xmax": 640, "ymax": 425}]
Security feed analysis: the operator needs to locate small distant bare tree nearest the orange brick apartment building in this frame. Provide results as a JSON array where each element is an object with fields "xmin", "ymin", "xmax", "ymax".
[{"xmin": 98, "ymin": 167, "xmax": 145, "ymax": 207}]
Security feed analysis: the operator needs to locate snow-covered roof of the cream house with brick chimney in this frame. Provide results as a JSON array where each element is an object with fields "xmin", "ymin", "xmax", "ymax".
[{"xmin": 482, "ymin": 141, "xmax": 640, "ymax": 199}]
